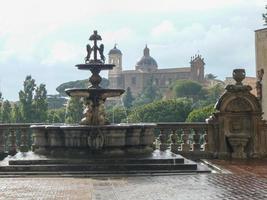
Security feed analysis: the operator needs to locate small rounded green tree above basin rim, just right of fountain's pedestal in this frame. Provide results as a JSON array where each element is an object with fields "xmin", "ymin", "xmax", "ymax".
[{"xmin": 107, "ymin": 106, "xmax": 128, "ymax": 123}]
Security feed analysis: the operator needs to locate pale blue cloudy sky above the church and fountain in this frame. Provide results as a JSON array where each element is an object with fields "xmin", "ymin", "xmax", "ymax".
[{"xmin": 0, "ymin": 0, "xmax": 267, "ymax": 100}]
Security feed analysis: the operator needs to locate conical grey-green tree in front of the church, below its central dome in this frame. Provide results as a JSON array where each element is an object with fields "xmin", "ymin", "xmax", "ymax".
[{"xmin": 134, "ymin": 76, "xmax": 162, "ymax": 106}]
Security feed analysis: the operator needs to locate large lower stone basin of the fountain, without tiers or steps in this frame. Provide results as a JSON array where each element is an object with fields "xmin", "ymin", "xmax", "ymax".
[{"xmin": 31, "ymin": 123, "xmax": 156, "ymax": 157}]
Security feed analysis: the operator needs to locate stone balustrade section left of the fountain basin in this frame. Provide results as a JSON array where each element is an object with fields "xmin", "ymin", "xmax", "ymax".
[{"xmin": 0, "ymin": 123, "xmax": 45, "ymax": 157}]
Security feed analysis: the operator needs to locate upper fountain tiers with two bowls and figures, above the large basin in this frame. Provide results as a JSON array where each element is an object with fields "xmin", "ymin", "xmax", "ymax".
[{"xmin": 65, "ymin": 31, "xmax": 124, "ymax": 125}]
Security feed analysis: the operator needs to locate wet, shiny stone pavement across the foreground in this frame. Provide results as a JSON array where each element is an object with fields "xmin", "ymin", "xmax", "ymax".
[{"xmin": 0, "ymin": 174, "xmax": 267, "ymax": 200}]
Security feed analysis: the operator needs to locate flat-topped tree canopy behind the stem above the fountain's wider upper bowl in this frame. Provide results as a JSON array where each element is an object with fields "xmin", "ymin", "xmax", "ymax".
[{"xmin": 56, "ymin": 77, "xmax": 109, "ymax": 96}]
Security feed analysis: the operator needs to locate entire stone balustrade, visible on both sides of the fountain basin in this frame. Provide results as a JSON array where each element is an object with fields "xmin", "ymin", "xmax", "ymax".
[{"xmin": 0, "ymin": 122, "xmax": 216, "ymax": 160}]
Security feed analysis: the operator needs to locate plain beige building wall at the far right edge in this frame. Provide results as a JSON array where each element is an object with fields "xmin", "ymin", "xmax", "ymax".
[{"xmin": 255, "ymin": 28, "xmax": 267, "ymax": 120}]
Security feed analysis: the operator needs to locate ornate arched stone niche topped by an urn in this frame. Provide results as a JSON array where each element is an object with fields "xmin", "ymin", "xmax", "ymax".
[{"xmin": 208, "ymin": 69, "xmax": 262, "ymax": 159}]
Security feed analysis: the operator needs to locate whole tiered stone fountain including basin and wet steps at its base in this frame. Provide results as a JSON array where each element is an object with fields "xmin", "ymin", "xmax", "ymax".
[{"xmin": 0, "ymin": 31, "xmax": 213, "ymax": 175}]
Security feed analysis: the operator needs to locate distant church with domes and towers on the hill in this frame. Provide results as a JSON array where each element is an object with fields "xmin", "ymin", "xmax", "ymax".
[{"xmin": 108, "ymin": 46, "xmax": 205, "ymax": 96}]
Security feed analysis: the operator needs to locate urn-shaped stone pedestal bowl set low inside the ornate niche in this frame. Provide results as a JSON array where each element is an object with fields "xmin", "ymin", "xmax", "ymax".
[{"xmin": 227, "ymin": 134, "xmax": 249, "ymax": 159}]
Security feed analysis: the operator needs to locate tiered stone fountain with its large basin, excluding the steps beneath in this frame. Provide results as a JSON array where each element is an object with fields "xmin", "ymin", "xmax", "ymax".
[{"xmin": 31, "ymin": 31, "xmax": 155, "ymax": 157}]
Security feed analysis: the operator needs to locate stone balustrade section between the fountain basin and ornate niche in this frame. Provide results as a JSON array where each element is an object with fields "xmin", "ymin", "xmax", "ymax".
[{"xmin": 155, "ymin": 122, "xmax": 213, "ymax": 158}]
